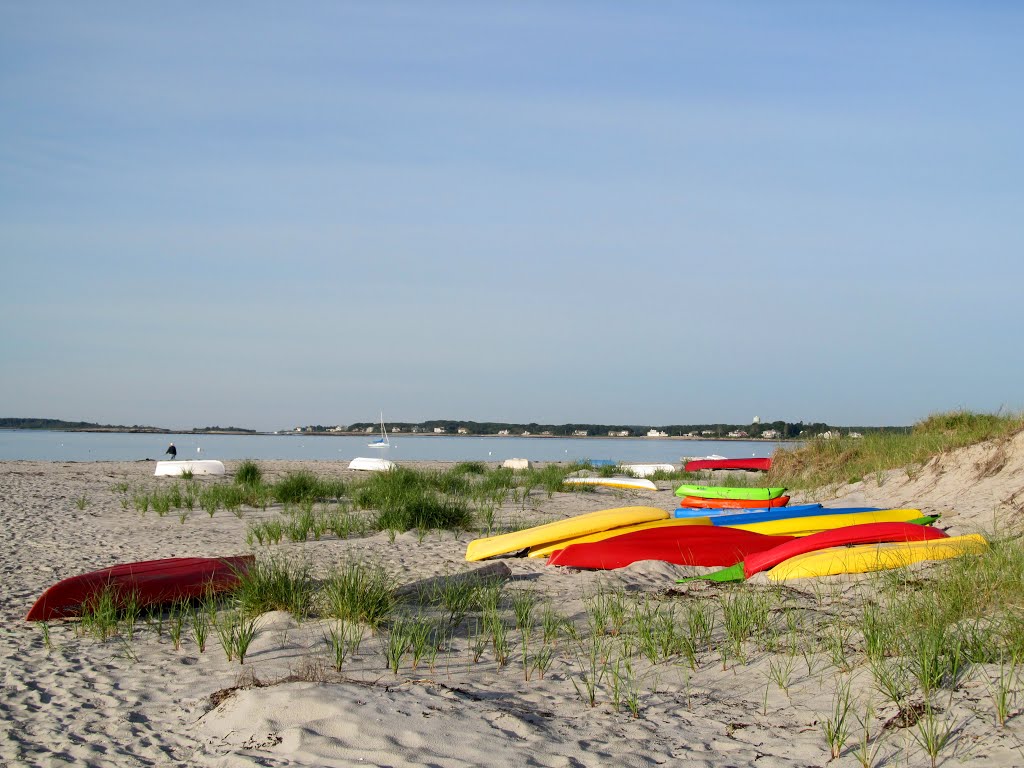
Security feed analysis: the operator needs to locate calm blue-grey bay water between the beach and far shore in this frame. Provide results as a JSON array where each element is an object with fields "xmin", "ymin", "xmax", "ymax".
[{"xmin": 0, "ymin": 430, "xmax": 779, "ymax": 463}]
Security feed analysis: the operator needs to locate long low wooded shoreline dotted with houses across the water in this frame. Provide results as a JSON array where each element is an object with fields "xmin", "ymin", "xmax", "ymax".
[{"xmin": 335, "ymin": 419, "xmax": 909, "ymax": 439}]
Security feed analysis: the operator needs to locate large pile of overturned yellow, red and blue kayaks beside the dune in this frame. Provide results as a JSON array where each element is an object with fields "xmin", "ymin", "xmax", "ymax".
[{"xmin": 466, "ymin": 486, "xmax": 987, "ymax": 581}]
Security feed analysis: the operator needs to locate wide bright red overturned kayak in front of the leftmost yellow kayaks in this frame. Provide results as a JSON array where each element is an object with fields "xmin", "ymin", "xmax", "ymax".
[{"xmin": 548, "ymin": 525, "xmax": 793, "ymax": 570}]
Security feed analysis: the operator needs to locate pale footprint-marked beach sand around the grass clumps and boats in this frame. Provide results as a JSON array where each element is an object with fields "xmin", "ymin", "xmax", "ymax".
[{"xmin": 0, "ymin": 442, "xmax": 1024, "ymax": 768}]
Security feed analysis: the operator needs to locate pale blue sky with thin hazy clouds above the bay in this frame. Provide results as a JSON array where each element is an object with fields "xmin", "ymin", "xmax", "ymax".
[{"xmin": 0, "ymin": 0, "xmax": 1024, "ymax": 429}]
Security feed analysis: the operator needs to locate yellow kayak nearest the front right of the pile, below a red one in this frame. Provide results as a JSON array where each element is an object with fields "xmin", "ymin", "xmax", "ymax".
[{"xmin": 768, "ymin": 534, "xmax": 988, "ymax": 582}]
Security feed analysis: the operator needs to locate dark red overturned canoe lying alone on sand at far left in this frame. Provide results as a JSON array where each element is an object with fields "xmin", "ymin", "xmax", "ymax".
[{"xmin": 25, "ymin": 555, "xmax": 254, "ymax": 622}]
